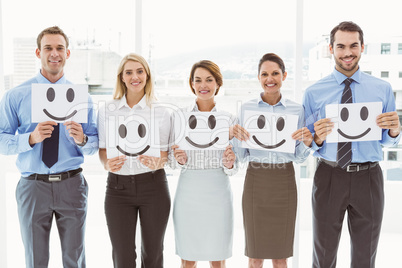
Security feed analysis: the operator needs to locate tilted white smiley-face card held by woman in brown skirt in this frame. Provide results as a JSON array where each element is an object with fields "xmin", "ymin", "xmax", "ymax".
[{"xmin": 241, "ymin": 110, "xmax": 299, "ymax": 153}]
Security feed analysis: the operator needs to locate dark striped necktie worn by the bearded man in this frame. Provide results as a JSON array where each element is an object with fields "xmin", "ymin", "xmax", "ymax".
[{"xmin": 336, "ymin": 78, "xmax": 353, "ymax": 168}]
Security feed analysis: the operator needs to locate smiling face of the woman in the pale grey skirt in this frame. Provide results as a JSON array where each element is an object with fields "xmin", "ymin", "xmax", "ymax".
[{"xmin": 192, "ymin": 68, "xmax": 219, "ymax": 102}]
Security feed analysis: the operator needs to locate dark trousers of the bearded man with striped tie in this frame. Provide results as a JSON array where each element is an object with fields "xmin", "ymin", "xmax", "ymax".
[{"xmin": 312, "ymin": 162, "xmax": 384, "ymax": 268}]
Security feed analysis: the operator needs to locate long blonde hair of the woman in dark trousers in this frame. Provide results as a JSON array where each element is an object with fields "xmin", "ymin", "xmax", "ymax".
[{"xmin": 113, "ymin": 53, "xmax": 156, "ymax": 106}]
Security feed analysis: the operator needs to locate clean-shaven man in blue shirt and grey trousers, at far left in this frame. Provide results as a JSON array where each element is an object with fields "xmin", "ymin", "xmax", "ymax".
[{"xmin": 0, "ymin": 26, "xmax": 98, "ymax": 268}]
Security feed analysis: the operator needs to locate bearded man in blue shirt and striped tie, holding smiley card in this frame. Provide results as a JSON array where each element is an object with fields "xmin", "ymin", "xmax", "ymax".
[{"xmin": 303, "ymin": 22, "xmax": 400, "ymax": 268}]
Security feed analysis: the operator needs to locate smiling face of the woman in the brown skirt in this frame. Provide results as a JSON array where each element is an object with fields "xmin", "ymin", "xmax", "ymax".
[{"xmin": 258, "ymin": 61, "xmax": 287, "ymax": 104}]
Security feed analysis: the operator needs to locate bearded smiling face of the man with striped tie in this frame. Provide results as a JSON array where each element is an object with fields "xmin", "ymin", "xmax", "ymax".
[{"xmin": 329, "ymin": 31, "xmax": 364, "ymax": 77}]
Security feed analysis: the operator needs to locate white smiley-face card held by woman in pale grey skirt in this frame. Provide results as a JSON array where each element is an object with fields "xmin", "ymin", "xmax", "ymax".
[{"xmin": 174, "ymin": 111, "xmax": 231, "ymax": 150}]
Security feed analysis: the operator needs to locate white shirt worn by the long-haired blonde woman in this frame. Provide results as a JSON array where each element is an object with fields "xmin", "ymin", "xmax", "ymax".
[{"xmin": 98, "ymin": 95, "xmax": 171, "ymax": 175}]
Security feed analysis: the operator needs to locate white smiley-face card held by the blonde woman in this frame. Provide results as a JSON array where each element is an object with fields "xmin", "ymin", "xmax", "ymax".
[{"xmin": 105, "ymin": 107, "xmax": 160, "ymax": 162}]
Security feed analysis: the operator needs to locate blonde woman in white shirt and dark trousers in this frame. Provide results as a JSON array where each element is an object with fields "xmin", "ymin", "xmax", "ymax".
[{"xmin": 98, "ymin": 54, "xmax": 170, "ymax": 268}]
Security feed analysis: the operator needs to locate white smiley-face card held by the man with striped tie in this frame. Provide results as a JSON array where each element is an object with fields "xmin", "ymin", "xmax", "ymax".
[{"xmin": 325, "ymin": 102, "xmax": 382, "ymax": 143}]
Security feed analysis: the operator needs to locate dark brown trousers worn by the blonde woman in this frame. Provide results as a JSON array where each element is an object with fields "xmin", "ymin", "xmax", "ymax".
[{"xmin": 105, "ymin": 169, "xmax": 170, "ymax": 268}]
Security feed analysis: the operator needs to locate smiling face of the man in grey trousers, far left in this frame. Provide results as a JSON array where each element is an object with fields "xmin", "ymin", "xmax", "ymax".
[{"xmin": 35, "ymin": 34, "xmax": 70, "ymax": 83}]
